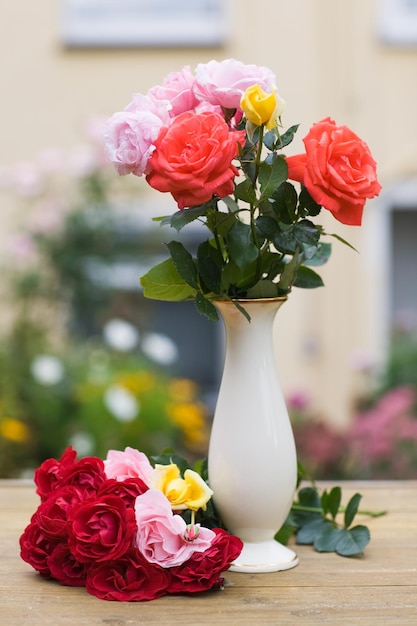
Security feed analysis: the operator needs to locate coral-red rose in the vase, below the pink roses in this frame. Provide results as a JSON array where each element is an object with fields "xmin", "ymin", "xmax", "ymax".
[{"xmin": 146, "ymin": 112, "xmax": 245, "ymax": 209}]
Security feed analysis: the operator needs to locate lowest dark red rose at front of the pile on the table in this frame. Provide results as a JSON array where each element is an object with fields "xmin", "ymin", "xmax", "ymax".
[{"xmin": 86, "ymin": 548, "xmax": 171, "ymax": 602}]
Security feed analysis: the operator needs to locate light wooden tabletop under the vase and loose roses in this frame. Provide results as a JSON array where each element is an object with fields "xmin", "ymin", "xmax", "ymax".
[{"xmin": 0, "ymin": 480, "xmax": 417, "ymax": 626}]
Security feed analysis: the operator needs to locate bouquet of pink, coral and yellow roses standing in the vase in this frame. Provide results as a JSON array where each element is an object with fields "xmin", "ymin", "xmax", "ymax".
[{"xmin": 105, "ymin": 59, "xmax": 381, "ymax": 319}]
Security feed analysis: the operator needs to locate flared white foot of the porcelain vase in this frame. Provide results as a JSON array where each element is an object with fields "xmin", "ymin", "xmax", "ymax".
[{"xmin": 229, "ymin": 539, "xmax": 298, "ymax": 574}]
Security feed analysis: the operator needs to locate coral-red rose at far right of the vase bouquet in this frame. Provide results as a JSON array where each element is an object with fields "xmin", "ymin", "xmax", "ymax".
[{"xmin": 286, "ymin": 117, "xmax": 381, "ymax": 226}]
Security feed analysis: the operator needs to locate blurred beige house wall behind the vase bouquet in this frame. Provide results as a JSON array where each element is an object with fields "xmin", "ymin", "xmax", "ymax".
[{"xmin": 0, "ymin": 0, "xmax": 417, "ymax": 424}]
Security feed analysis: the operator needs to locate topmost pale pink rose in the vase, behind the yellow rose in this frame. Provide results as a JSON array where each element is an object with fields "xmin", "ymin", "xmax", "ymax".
[{"xmin": 194, "ymin": 59, "xmax": 276, "ymax": 109}]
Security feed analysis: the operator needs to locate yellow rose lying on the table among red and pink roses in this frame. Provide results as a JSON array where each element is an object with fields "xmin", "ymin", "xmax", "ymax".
[{"xmin": 151, "ymin": 463, "xmax": 213, "ymax": 511}]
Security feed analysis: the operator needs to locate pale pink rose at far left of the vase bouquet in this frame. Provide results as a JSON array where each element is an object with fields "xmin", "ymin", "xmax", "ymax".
[{"xmin": 104, "ymin": 94, "xmax": 170, "ymax": 176}]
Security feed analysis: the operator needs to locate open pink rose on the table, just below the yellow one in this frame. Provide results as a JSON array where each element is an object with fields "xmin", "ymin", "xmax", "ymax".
[{"xmin": 135, "ymin": 489, "xmax": 216, "ymax": 568}]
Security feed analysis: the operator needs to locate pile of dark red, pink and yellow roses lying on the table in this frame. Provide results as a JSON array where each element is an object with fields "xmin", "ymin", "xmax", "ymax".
[{"xmin": 20, "ymin": 448, "xmax": 243, "ymax": 601}]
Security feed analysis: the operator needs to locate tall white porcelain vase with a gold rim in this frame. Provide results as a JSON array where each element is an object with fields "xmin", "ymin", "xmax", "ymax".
[{"xmin": 208, "ymin": 298, "xmax": 298, "ymax": 573}]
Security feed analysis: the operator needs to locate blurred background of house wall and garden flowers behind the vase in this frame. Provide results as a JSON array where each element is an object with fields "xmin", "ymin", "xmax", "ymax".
[{"xmin": 0, "ymin": 0, "xmax": 417, "ymax": 479}]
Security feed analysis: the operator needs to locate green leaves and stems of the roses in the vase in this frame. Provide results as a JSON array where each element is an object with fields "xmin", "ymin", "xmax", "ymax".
[{"xmin": 141, "ymin": 126, "xmax": 352, "ymax": 320}]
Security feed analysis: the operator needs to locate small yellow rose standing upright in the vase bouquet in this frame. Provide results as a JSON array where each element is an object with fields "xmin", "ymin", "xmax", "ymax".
[{"xmin": 240, "ymin": 85, "xmax": 285, "ymax": 129}]
